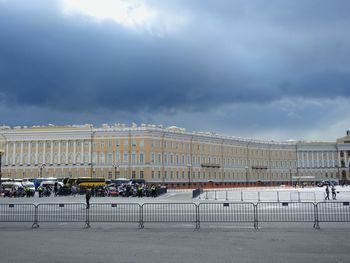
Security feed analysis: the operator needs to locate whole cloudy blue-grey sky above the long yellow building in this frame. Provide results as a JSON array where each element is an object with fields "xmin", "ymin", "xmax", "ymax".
[{"xmin": 0, "ymin": 0, "xmax": 350, "ymax": 141}]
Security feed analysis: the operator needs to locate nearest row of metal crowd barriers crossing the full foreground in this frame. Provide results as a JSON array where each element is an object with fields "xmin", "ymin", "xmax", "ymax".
[{"xmin": 0, "ymin": 201, "xmax": 350, "ymax": 229}]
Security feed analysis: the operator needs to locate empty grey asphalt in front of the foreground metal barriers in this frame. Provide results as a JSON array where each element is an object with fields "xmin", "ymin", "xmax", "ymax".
[{"xmin": 0, "ymin": 223, "xmax": 350, "ymax": 263}]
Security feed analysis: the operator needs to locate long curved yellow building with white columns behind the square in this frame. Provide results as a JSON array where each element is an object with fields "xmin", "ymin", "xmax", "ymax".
[{"xmin": 0, "ymin": 124, "xmax": 350, "ymax": 186}]
